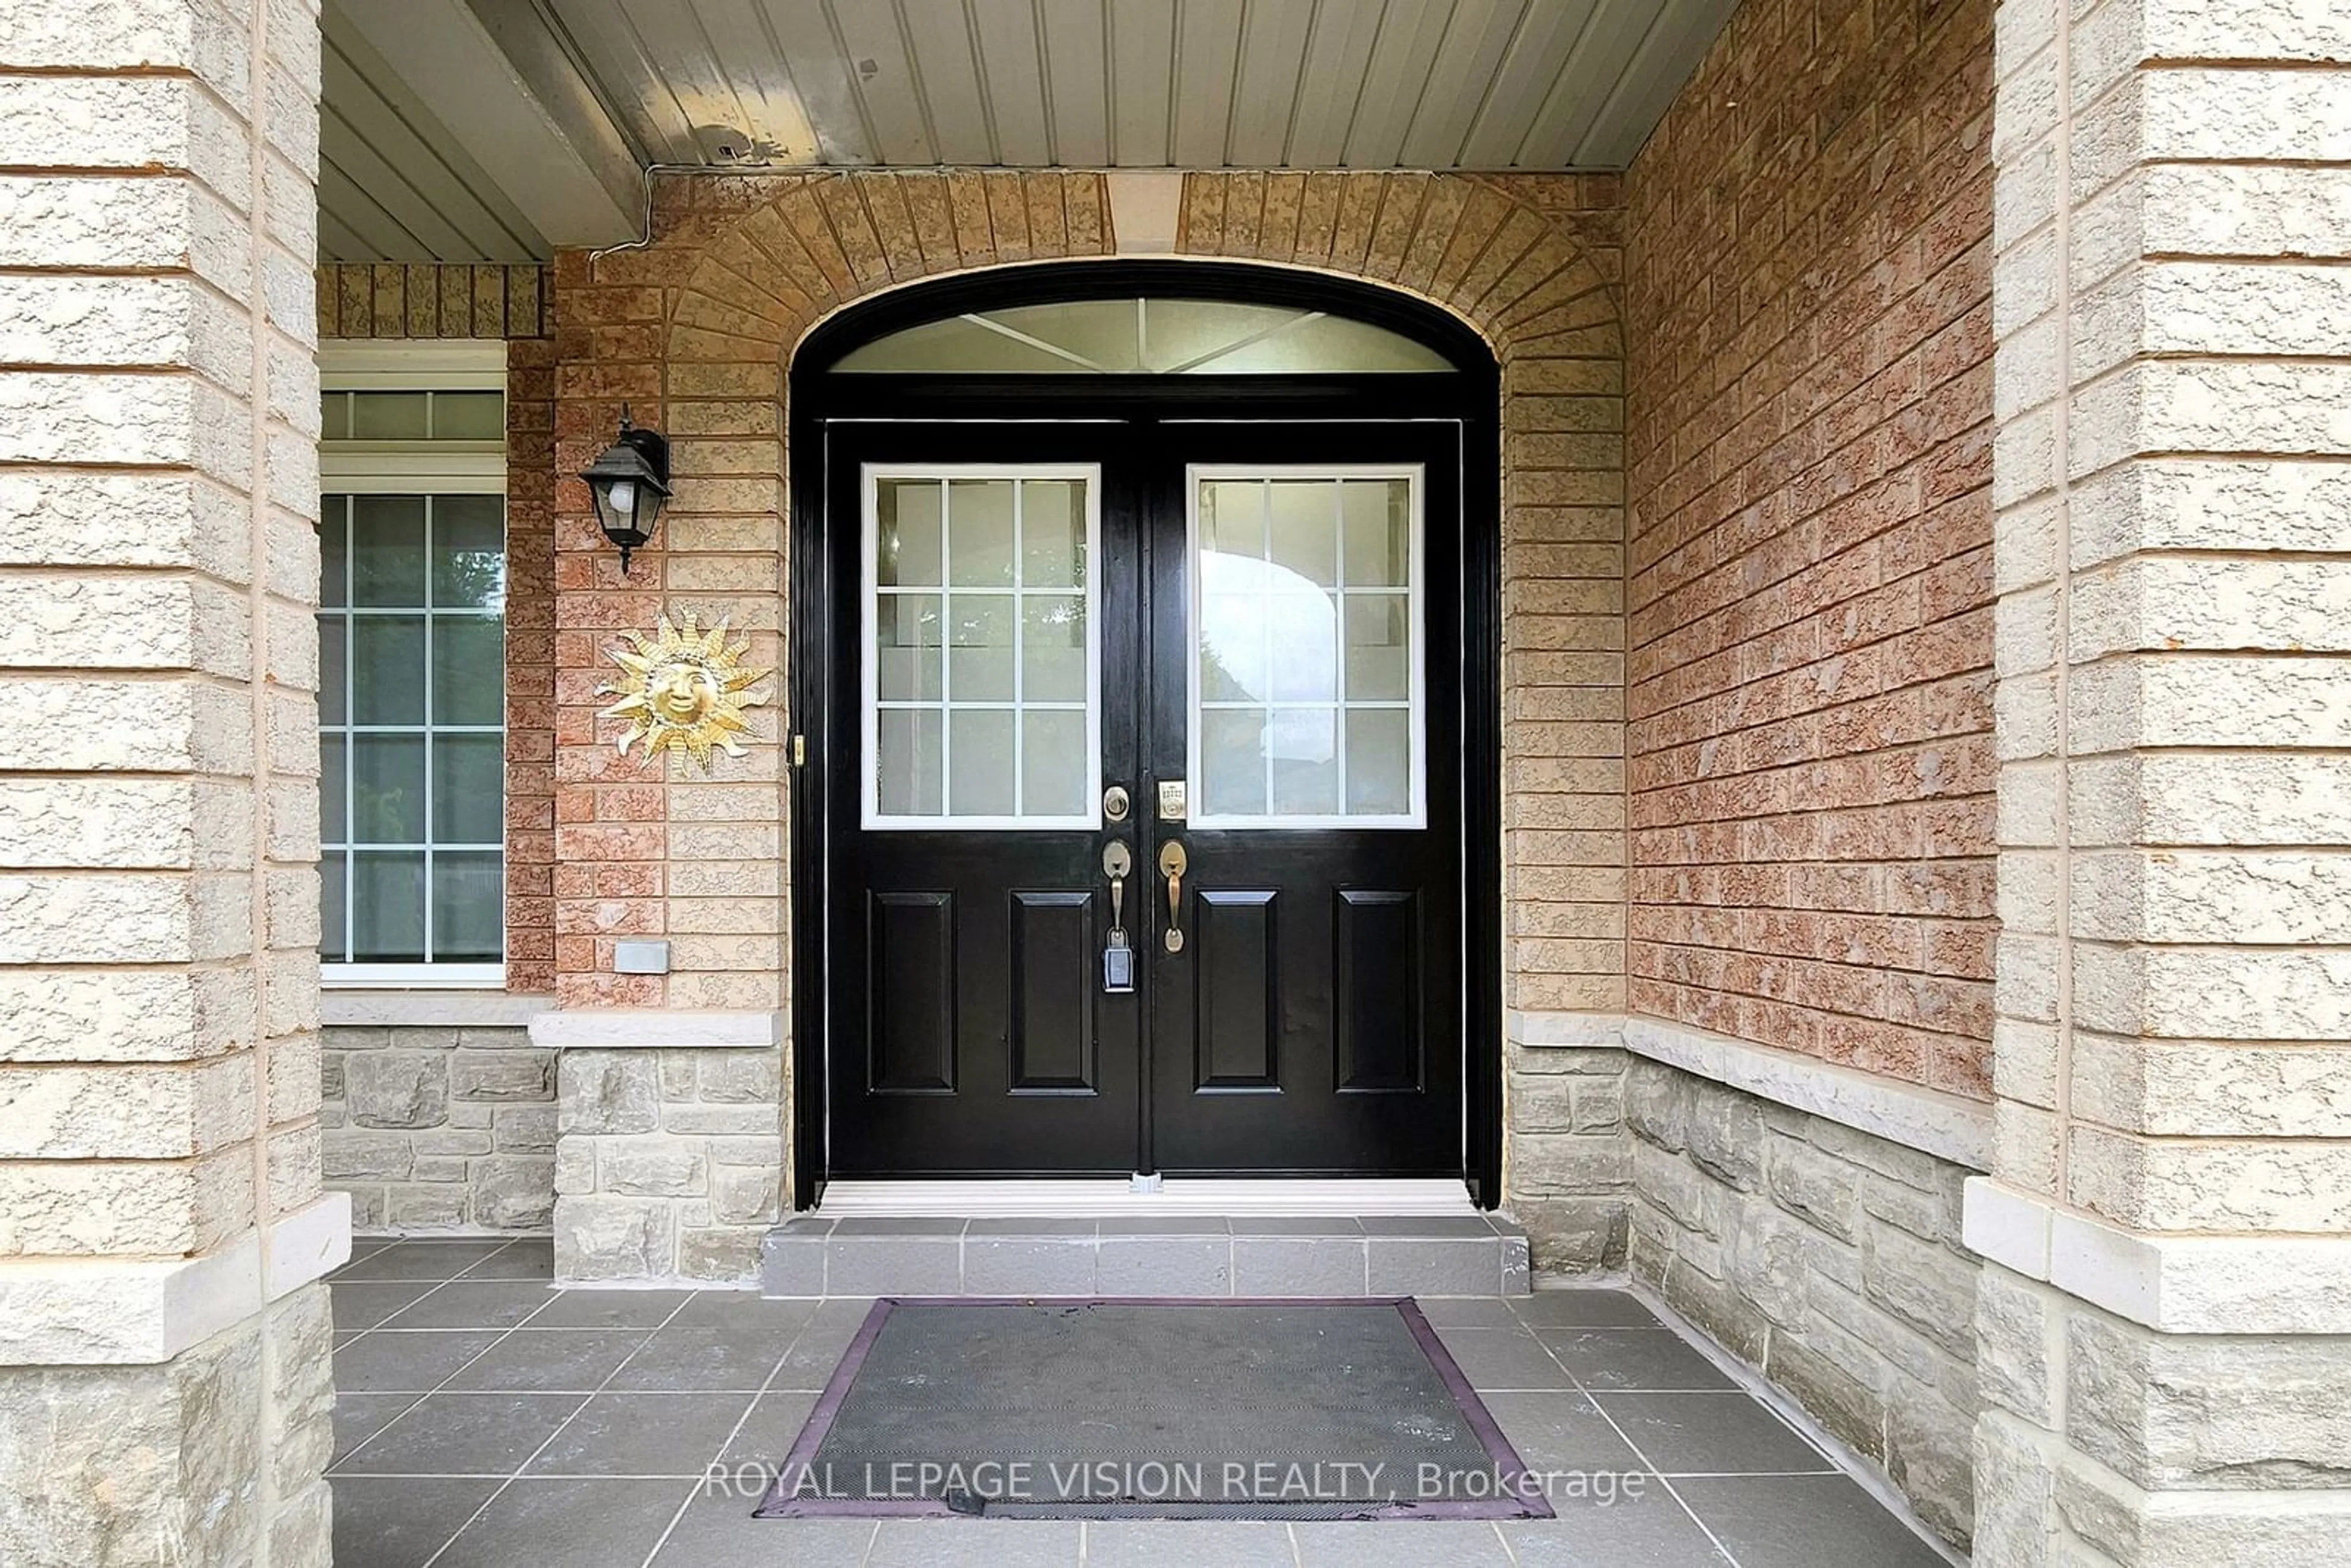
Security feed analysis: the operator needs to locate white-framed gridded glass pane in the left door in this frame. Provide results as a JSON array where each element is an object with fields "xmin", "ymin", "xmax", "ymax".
[{"xmin": 860, "ymin": 463, "xmax": 1103, "ymax": 830}]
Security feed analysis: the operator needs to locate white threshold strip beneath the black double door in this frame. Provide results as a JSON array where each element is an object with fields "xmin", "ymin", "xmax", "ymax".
[{"xmin": 816, "ymin": 1176, "xmax": 1479, "ymax": 1220}]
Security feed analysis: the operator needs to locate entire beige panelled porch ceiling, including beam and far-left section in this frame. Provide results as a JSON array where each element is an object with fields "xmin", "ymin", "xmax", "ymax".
[{"xmin": 320, "ymin": 0, "xmax": 1738, "ymax": 261}]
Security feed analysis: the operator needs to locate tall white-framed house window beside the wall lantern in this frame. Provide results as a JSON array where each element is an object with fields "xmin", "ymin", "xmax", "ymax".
[{"xmin": 317, "ymin": 341, "xmax": 506, "ymax": 988}]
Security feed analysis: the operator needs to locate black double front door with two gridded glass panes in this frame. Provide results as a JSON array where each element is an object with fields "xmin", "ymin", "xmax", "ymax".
[{"xmin": 820, "ymin": 416, "xmax": 1464, "ymax": 1178}]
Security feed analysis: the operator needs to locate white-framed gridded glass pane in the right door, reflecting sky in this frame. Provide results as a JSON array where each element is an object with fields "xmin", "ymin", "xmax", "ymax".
[{"xmin": 1185, "ymin": 463, "xmax": 1427, "ymax": 830}]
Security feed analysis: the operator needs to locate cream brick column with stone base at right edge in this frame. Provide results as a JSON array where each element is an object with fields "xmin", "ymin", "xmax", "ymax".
[{"xmin": 1965, "ymin": 0, "xmax": 2351, "ymax": 1568}]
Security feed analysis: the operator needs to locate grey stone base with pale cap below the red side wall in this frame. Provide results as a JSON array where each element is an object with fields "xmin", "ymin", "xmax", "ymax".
[{"xmin": 1509, "ymin": 1013, "xmax": 1989, "ymax": 1547}]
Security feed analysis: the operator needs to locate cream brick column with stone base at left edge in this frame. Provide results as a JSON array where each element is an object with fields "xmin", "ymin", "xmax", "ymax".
[{"xmin": 0, "ymin": 0, "xmax": 348, "ymax": 1568}]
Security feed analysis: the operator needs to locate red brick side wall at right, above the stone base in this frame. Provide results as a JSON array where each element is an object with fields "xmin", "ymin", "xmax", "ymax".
[{"xmin": 1624, "ymin": 0, "xmax": 1993, "ymax": 1095}]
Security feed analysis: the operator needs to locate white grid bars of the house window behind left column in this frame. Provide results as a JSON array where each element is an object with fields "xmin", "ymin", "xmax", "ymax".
[{"xmin": 317, "ymin": 489, "xmax": 508, "ymax": 971}]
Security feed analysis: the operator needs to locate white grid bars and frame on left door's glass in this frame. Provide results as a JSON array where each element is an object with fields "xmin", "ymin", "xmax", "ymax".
[{"xmin": 860, "ymin": 463, "xmax": 1103, "ymax": 830}]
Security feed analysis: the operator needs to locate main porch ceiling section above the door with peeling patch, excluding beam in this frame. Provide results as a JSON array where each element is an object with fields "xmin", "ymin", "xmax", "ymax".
[{"xmin": 541, "ymin": 0, "xmax": 1730, "ymax": 169}]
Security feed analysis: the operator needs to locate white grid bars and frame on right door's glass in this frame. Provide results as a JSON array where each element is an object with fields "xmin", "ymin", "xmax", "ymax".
[{"xmin": 1185, "ymin": 463, "xmax": 1427, "ymax": 830}]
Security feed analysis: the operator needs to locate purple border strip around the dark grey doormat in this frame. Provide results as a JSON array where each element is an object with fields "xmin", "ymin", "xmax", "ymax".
[{"xmin": 752, "ymin": 1296, "xmax": 1556, "ymax": 1521}]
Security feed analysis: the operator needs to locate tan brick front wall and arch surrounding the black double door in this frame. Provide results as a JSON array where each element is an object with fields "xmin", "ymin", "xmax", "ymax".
[{"xmin": 555, "ymin": 171, "xmax": 1624, "ymax": 1209}]
